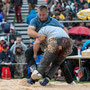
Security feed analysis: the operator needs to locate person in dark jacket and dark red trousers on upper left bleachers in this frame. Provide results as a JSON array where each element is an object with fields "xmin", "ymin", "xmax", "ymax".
[{"xmin": 12, "ymin": 0, "xmax": 23, "ymax": 22}]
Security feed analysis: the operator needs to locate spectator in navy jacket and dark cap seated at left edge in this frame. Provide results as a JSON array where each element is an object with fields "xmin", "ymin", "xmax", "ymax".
[{"xmin": 0, "ymin": 44, "xmax": 14, "ymax": 78}]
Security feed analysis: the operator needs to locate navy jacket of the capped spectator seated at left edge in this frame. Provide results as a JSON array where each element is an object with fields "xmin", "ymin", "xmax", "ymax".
[{"xmin": 0, "ymin": 50, "xmax": 14, "ymax": 63}]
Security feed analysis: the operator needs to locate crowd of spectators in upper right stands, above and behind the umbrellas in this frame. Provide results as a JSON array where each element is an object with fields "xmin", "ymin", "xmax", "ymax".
[{"xmin": 48, "ymin": 0, "xmax": 90, "ymax": 29}]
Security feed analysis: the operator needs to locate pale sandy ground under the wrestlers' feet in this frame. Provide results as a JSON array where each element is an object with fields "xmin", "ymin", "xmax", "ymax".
[{"xmin": 0, "ymin": 79, "xmax": 90, "ymax": 90}]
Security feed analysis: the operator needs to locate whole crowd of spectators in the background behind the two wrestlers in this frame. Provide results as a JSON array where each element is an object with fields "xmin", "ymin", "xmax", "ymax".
[{"xmin": 0, "ymin": 0, "xmax": 90, "ymax": 82}]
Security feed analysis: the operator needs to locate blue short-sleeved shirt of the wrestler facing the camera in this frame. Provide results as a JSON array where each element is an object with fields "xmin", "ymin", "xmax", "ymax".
[{"xmin": 30, "ymin": 16, "xmax": 64, "ymax": 32}]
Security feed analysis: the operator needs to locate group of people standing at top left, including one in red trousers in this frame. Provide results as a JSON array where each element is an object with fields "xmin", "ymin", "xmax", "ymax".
[{"xmin": 0, "ymin": 0, "xmax": 23, "ymax": 23}]
